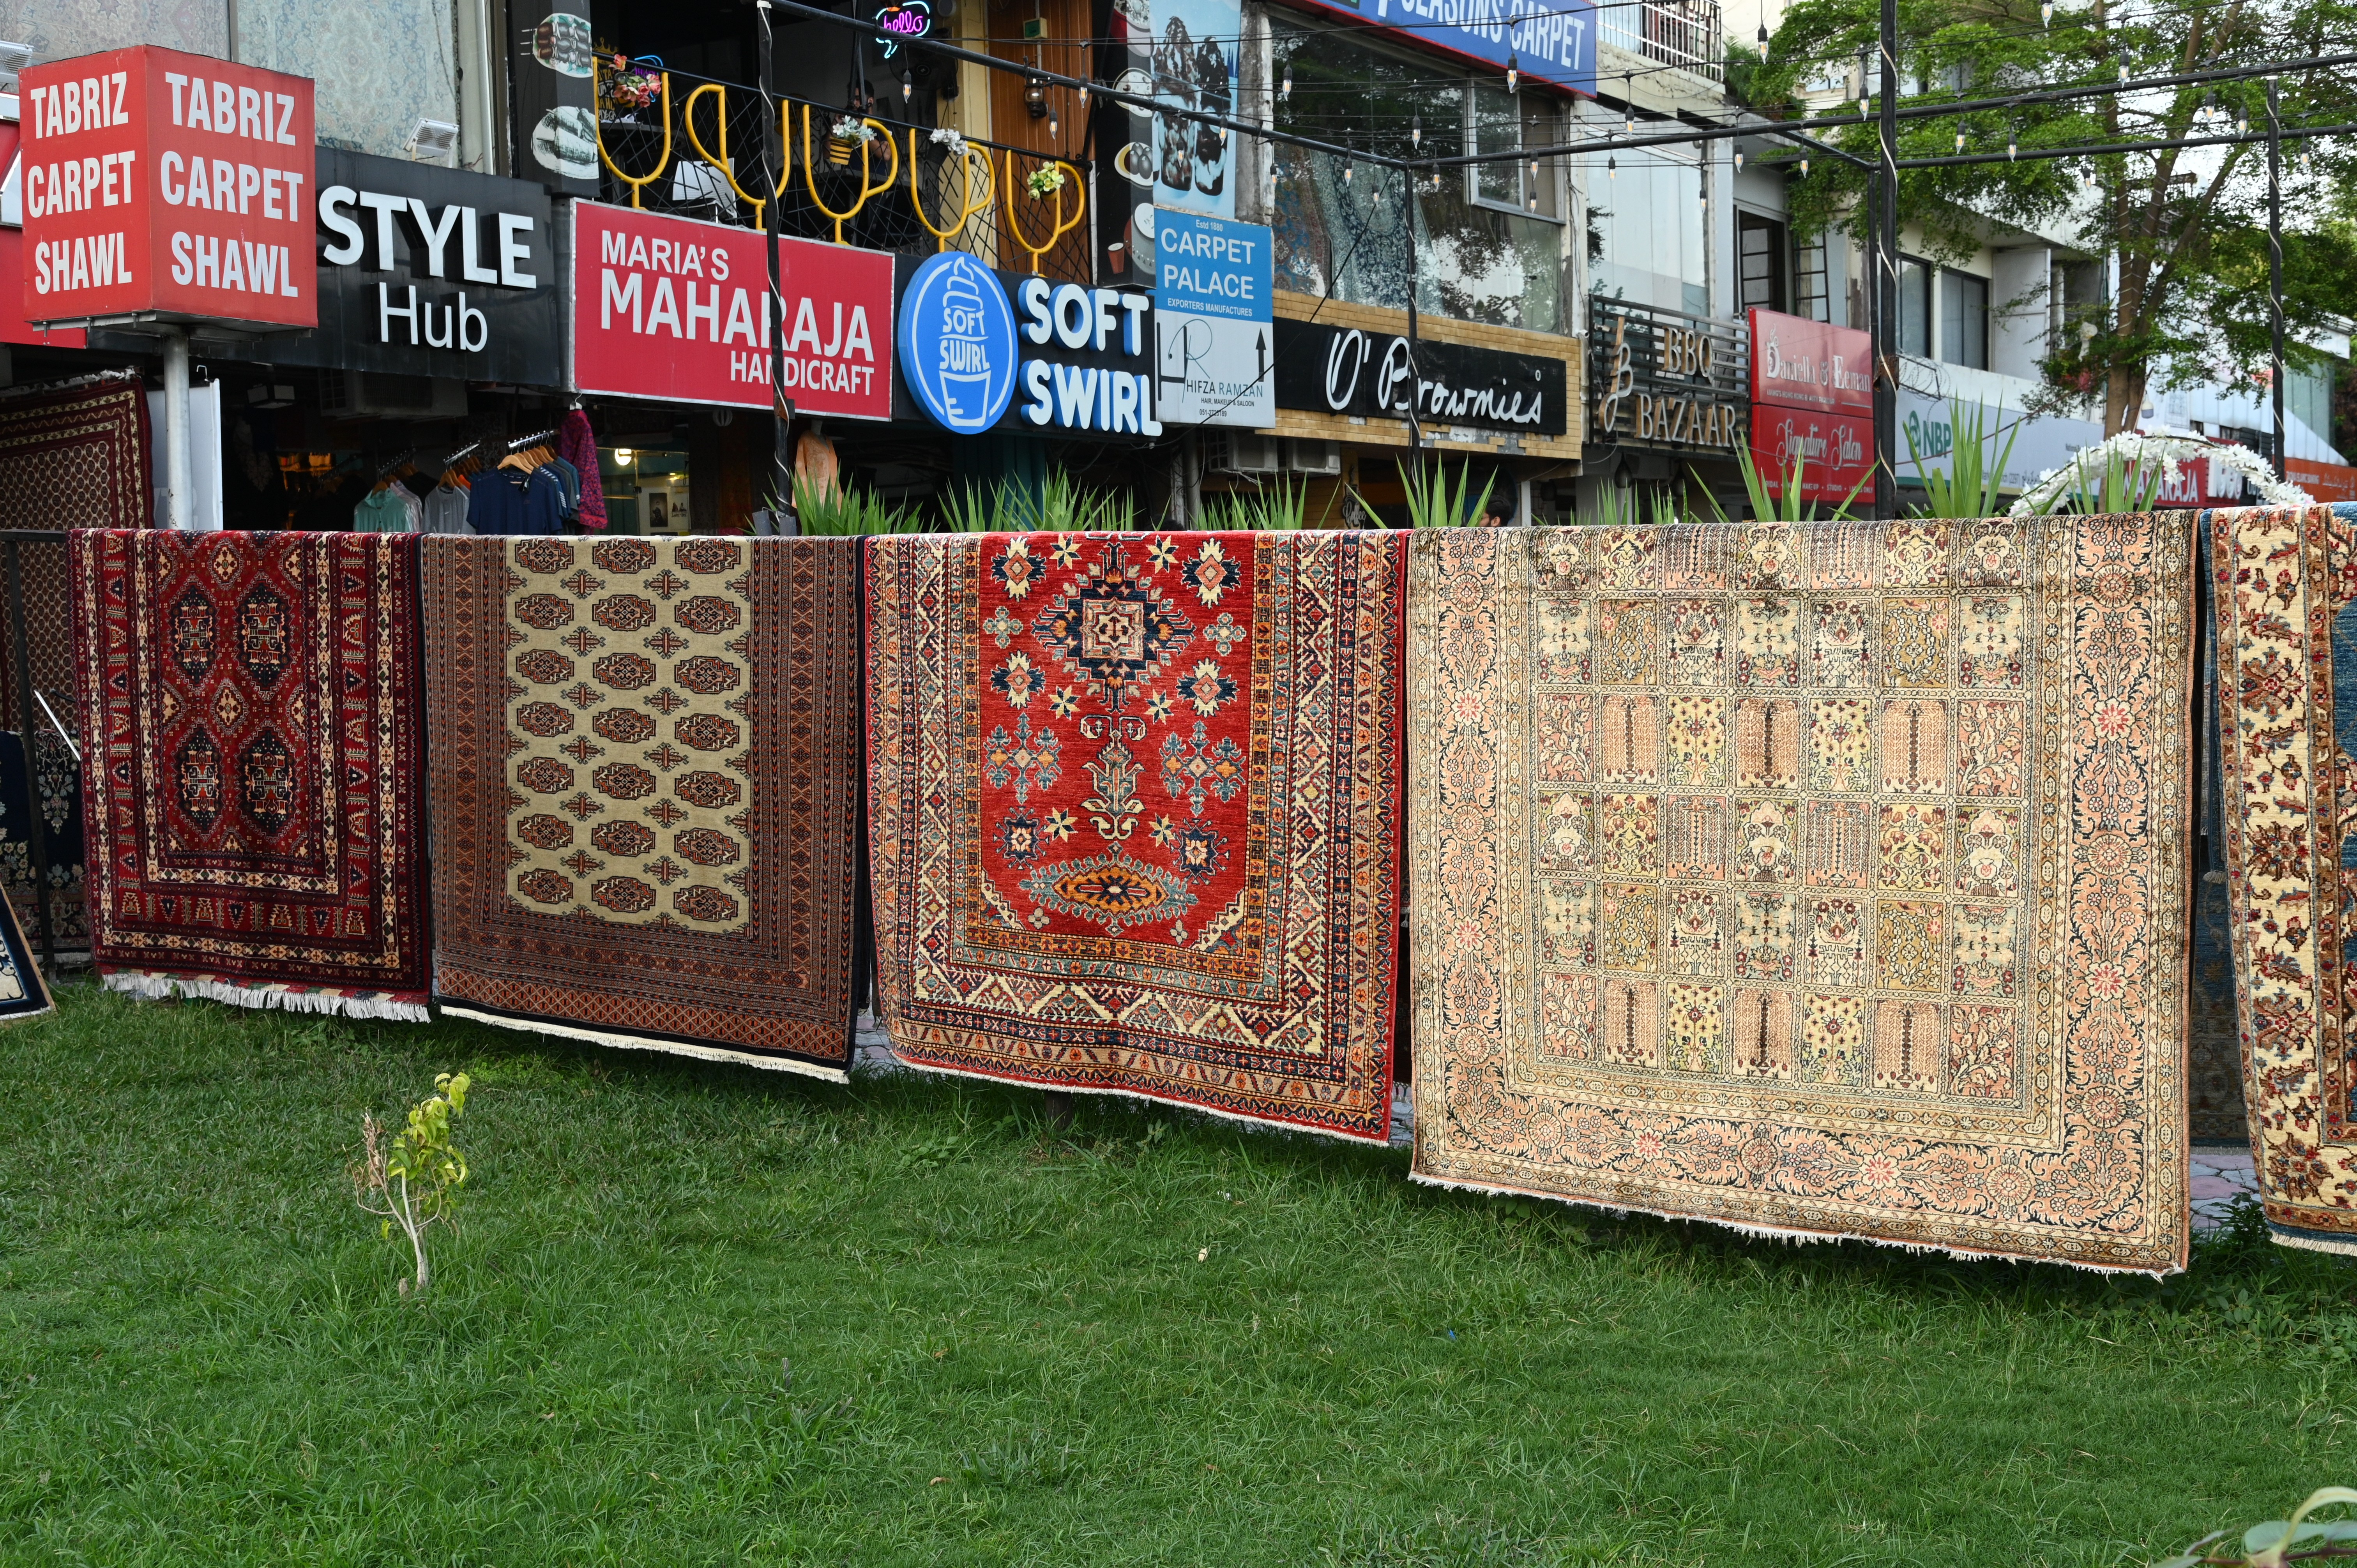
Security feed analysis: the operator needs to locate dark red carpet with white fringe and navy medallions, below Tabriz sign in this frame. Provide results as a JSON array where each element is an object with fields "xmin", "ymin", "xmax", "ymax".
[{"xmin": 71, "ymin": 531, "xmax": 431, "ymax": 1021}]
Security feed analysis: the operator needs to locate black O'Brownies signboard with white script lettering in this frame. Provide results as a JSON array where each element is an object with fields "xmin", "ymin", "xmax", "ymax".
[{"xmin": 1275, "ymin": 321, "xmax": 1570, "ymax": 436}]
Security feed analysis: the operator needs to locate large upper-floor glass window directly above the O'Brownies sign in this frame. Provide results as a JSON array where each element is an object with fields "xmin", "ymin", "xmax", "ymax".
[{"xmin": 1270, "ymin": 16, "xmax": 1572, "ymax": 332}]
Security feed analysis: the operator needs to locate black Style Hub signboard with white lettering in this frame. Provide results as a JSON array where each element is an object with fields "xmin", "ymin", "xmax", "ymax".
[{"xmin": 240, "ymin": 146, "xmax": 566, "ymax": 387}]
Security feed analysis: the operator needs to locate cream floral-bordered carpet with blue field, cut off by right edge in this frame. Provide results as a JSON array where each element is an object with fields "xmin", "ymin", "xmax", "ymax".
[{"xmin": 2209, "ymin": 505, "xmax": 2357, "ymax": 1252}]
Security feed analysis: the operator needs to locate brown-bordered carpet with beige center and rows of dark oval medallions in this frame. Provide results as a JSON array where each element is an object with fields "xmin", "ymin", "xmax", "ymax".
[{"xmin": 424, "ymin": 538, "xmax": 860, "ymax": 1080}]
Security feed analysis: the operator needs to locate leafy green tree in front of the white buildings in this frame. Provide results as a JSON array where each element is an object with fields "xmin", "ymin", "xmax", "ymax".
[{"xmin": 1742, "ymin": 0, "xmax": 2357, "ymax": 434}]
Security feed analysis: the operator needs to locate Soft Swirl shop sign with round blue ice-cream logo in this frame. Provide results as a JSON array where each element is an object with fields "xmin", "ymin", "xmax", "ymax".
[{"xmin": 900, "ymin": 250, "xmax": 1162, "ymax": 436}]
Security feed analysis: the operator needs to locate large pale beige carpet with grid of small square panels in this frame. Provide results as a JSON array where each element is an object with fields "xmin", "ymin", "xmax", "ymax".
[{"xmin": 1407, "ymin": 516, "xmax": 2192, "ymax": 1271}]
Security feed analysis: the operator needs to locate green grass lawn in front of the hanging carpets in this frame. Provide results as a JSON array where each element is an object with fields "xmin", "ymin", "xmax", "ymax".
[{"xmin": 0, "ymin": 988, "xmax": 2357, "ymax": 1568}]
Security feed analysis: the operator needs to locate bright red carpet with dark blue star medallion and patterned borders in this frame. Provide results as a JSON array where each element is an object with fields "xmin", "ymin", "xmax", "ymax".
[{"xmin": 868, "ymin": 533, "xmax": 1405, "ymax": 1139}]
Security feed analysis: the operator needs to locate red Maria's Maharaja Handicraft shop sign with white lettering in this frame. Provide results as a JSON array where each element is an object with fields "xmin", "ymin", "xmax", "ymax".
[{"xmin": 573, "ymin": 200, "xmax": 893, "ymax": 420}]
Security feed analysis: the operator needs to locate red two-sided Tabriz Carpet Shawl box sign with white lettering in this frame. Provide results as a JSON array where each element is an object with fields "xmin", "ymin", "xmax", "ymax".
[{"xmin": 21, "ymin": 45, "xmax": 318, "ymax": 328}]
